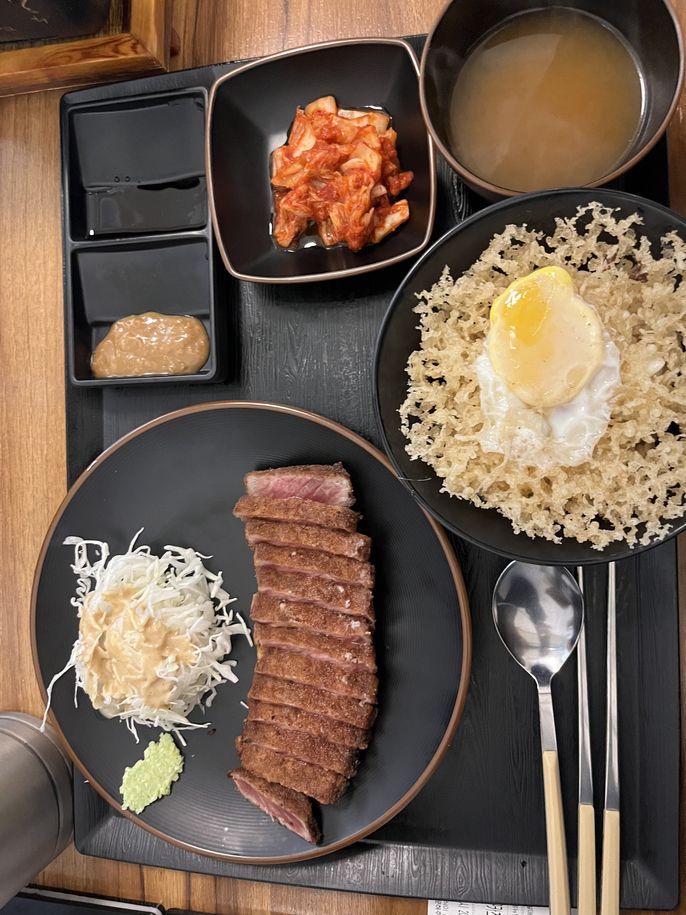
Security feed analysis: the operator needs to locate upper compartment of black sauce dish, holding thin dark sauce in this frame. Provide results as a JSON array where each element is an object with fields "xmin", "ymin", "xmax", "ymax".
[{"xmin": 67, "ymin": 90, "xmax": 208, "ymax": 239}]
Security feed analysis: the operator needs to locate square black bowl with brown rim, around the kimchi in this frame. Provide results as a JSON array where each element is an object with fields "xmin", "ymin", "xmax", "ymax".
[{"xmin": 206, "ymin": 38, "xmax": 436, "ymax": 283}]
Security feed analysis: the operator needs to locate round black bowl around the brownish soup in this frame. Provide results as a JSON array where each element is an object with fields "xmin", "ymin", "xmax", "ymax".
[{"xmin": 420, "ymin": 0, "xmax": 683, "ymax": 200}]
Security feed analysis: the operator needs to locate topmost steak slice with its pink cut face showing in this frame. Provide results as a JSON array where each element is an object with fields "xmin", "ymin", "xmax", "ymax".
[{"xmin": 245, "ymin": 464, "xmax": 355, "ymax": 507}]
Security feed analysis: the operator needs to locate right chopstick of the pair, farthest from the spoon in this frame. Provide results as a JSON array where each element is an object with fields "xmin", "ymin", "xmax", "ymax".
[{"xmin": 600, "ymin": 562, "xmax": 619, "ymax": 915}]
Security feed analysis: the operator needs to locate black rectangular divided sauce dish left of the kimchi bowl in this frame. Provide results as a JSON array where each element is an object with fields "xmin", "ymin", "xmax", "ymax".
[{"xmin": 62, "ymin": 88, "xmax": 226, "ymax": 387}]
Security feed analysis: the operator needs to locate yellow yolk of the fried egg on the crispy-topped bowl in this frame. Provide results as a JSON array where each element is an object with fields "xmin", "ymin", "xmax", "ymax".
[{"xmin": 488, "ymin": 267, "xmax": 603, "ymax": 409}]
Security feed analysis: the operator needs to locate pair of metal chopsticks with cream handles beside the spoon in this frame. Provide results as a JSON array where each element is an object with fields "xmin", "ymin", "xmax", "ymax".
[{"xmin": 577, "ymin": 562, "xmax": 620, "ymax": 915}]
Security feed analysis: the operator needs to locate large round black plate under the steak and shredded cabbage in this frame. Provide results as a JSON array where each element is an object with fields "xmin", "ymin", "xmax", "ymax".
[{"xmin": 32, "ymin": 402, "xmax": 471, "ymax": 863}]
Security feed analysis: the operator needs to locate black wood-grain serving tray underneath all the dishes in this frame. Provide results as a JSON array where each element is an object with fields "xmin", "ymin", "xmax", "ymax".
[{"xmin": 62, "ymin": 39, "xmax": 679, "ymax": 909}]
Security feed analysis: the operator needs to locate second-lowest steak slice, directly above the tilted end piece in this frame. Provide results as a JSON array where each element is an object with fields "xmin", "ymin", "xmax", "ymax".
[{"xmin": 237, "ymin": 737, "xmax": 348, "ymax": 804}]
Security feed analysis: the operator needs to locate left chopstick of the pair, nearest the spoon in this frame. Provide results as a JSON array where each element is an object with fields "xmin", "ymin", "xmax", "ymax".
[{"xmin": 576, "ymin": 566, "xmax": 596, "ymax": 915}]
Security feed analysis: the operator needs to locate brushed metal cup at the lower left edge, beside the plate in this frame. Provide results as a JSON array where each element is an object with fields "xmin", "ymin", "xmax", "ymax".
[{"xmin": 0, "ymin": 712, "xmax": 73, "ymax": 908}]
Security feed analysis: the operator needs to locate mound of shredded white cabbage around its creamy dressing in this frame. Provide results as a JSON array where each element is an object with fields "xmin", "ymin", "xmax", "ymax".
[{"xmin": 42, "ymin": 528, "xmax": 252, "ymax": 744}]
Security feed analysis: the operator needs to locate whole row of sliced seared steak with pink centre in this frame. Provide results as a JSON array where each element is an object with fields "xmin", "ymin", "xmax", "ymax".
[{"xmin": 229, "ymin": 464, "xmax": 378, "ymax": 843}]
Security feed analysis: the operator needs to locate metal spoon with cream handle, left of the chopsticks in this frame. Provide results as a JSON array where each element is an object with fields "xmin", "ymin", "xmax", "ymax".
[{"xmin": 493, "ymin": 562, "xmax": 584, "ymax": 915}]
